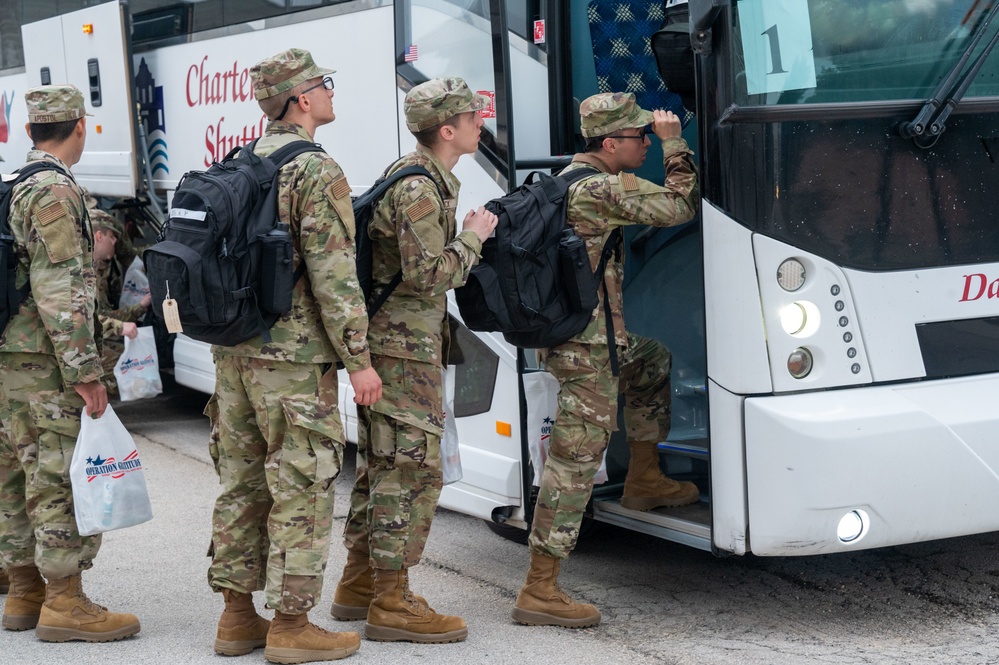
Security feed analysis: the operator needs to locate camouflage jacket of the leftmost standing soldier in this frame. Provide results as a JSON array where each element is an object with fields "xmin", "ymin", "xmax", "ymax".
[{"xmin": 0, "ymin": 150, "xmax": 103, "ymax": 386}]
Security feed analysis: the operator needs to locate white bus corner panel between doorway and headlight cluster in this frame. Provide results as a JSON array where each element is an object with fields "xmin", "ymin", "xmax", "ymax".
[{"xmin": 701, "ymin": 201, "xmax": 772, "ymax": 394}]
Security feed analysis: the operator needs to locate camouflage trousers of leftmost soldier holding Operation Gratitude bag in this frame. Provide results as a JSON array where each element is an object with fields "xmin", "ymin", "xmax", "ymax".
[{"xmin": 0, "ymin": 353, "xmax": 101, "ymax": 579}]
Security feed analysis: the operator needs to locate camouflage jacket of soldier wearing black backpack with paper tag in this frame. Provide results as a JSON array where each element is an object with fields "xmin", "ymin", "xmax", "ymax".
[{"xmin": 213, "ymin": 121, "xmax": 371, "ymax": 372}]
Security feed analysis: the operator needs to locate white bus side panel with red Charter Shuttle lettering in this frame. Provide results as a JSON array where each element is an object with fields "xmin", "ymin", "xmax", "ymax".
[{"xmin": 134, "ymin": 7, "xmax": 398, "ymax": 194}]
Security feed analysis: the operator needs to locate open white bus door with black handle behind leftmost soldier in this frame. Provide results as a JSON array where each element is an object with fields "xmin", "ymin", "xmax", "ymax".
[{"xmin": 21, "ymin": 0, "xmax": 138, "ymax": 197}]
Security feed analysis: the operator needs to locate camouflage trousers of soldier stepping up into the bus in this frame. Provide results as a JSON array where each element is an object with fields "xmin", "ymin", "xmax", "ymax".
[{"xmin": 528, "ymin": 333, "xmax": 671, "ymax": 559}]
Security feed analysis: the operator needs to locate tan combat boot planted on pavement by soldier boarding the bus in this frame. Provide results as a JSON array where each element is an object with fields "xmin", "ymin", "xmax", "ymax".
[{"xmin": 511, "ymin": 552, "xmax": 600, "ymax": 628}]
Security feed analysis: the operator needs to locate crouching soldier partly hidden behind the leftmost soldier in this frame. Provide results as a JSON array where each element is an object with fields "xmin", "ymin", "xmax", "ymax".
[{"xmin": 89, "ymin": 208, "xmax": 150, "ymax": 399}]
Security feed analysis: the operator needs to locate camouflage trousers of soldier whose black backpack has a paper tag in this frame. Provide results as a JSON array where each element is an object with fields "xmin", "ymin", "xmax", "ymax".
[{"xmin": 206, "ymin": 356, "xmax": 343, "ymax": 614}]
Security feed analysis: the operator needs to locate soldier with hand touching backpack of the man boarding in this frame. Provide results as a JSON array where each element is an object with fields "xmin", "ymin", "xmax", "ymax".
[{"xmin": 332, "ymin": 78, "xmax": 496, "ymax": 643}]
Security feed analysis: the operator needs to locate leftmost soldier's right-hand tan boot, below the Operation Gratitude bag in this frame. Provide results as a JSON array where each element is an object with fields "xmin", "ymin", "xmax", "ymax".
[{"xmin": 35, "ymin": 575, "xmax": 140, "ymax": 642}]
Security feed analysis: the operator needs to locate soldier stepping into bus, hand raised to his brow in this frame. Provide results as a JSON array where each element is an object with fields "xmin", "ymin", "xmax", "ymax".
[{"xmin": 513, "ymin": 93, "xmax": 699, "ymax": 628}]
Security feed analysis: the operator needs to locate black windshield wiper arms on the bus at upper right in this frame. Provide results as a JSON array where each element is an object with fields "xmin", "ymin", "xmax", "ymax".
[{"xmin": 898, "ymin": 2, "xmax": 999, "ymax": 148}]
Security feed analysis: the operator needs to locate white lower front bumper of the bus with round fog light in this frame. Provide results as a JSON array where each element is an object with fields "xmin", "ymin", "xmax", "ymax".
[{"xmin": 745, "ymin": 374, "xmax": 999, "ymax": 556}]
